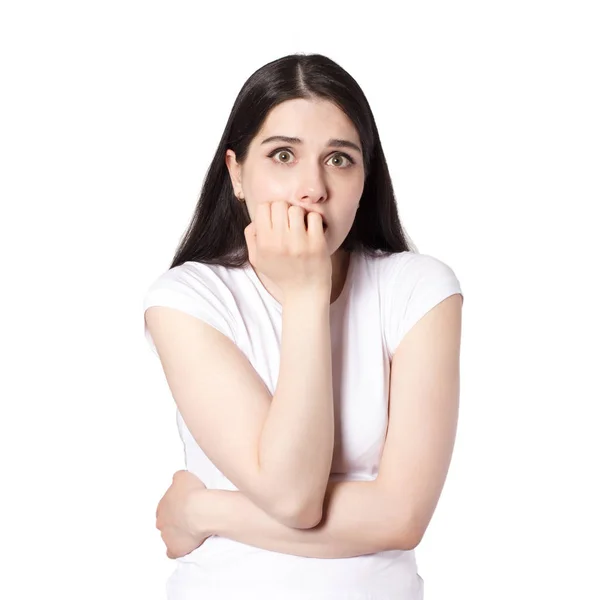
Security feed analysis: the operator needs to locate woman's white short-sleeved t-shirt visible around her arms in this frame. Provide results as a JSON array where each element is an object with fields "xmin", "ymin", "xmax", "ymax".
[{"xmin": 144, "ymin": 251, "xmax": 462, "ymax": 600}]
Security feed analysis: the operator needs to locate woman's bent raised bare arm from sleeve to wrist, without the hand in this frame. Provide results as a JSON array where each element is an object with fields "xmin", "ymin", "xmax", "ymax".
[{"xmin": 145, "ymin": 290, "xmax": 334, "ymax": 528}]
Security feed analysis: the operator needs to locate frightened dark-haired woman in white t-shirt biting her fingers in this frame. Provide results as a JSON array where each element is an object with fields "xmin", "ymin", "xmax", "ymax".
[{"xmin": 144, "ymin": 54, "xmax": 462, "ymax": 600}]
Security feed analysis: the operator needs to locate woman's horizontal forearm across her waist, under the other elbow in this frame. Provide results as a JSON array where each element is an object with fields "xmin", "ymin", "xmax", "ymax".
[{"xmin": 190, "ymin": 481, "xmax": 404, "ymax": 558}]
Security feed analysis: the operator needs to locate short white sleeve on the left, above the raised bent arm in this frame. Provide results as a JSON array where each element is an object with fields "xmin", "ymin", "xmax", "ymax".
[{"xmin": 143, "ymin": 264, "xmax": 235, "ymax": 355}]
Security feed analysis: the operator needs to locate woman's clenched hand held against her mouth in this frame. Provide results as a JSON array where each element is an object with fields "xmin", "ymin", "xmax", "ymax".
[{"xmin": 244, "ymin": 201, "xmax": 332, "ymax": 297}]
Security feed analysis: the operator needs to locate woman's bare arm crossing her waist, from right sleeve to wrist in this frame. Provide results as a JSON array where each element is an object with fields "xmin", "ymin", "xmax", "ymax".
[{"xmin": 183, "ymin": 294, "xmax": 462, "ymax": 558}]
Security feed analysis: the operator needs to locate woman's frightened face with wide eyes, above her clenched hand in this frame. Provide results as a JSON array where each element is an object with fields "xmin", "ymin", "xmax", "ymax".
[{"xmin": 226, "ymin": 99, "xmax": 364, "ymax": 254}]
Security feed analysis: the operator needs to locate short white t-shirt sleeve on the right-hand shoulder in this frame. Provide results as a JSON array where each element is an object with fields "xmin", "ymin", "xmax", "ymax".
[{"xmin": 385, "ymin": 253, "xmax": 464, "ymax": 357}]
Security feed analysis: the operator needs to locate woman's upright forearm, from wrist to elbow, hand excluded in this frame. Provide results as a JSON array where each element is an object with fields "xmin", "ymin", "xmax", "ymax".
[{"xmin": 258, "ymin": 290, "xmax": 334, "ymax": 514}]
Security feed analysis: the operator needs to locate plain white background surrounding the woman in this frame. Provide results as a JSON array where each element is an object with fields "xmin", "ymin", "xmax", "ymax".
[{"xmin": 0, "ymin": 0, "xmax": 600, "ymax": 600}]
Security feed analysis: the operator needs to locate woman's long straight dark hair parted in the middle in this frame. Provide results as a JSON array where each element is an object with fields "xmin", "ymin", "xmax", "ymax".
[{"xmin": 170, "ymin": 53, "xmax": 414, "ymax": 268}]
